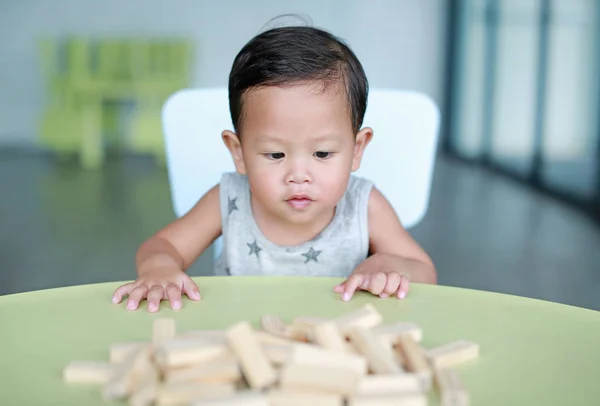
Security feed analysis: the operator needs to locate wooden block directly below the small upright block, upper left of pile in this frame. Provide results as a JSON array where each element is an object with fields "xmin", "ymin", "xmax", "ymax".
[{"xmin": 155, "ymin": 337, "xmax": 231, "ymax": 368}]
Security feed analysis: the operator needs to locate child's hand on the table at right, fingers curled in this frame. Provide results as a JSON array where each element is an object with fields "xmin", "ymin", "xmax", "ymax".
[{"xmin": 334, "ymin": 254, "xmax": 410, "ymax": 301}]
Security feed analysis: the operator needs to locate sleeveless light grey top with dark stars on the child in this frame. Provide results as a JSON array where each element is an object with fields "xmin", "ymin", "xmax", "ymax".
[{"xmin": 215, "ymin": 172, "xmax": 373, "ymax": 277}]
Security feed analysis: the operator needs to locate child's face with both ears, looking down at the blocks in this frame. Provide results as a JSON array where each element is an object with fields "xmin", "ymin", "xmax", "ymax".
[{"xmin": 223, "ymin": 84, "xmax": 372, "ymax": 223}]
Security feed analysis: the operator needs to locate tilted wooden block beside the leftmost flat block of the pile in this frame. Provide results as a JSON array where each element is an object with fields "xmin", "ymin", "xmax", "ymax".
[{"xmin": 102, "ymin": 345, "xmax": 150, "ymax": 400}]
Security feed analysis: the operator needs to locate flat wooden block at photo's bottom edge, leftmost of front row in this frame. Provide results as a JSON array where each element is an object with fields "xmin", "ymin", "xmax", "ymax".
[{"xmin": 156, "ymin": 383, "xmax": 235, "ymax": 406}]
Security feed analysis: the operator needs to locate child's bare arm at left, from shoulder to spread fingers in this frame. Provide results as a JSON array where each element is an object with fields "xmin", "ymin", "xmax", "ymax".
[{"xmin": 113, "ymin": 185, "xmax": 221, "ymax": 312}]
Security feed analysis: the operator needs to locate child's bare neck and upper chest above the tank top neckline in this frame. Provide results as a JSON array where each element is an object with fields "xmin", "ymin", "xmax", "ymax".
[{"xmin": 251, "ymin": 195, "xmax": 335, "ymax": 246}]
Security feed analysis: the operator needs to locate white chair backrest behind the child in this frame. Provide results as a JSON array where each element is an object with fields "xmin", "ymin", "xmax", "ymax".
[{"xmin": 162, "ymin": 88, "xmax": 440, "ymax": 228}]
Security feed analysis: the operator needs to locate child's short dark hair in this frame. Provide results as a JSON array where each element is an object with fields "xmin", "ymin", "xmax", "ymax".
[{"xmin": 229, "ymin": 26, "xmax": 369, "ymax": 136}]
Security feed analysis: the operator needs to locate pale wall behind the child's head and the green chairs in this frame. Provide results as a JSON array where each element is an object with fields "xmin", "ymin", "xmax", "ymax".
[{"xmin": 0, "ymin": 0, "xmax": 446, "ymax": 145}]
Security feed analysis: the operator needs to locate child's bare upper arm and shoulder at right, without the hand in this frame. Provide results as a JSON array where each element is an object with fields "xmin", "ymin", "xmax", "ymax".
[{"xmin": 368, "ymin": 187, "xmax": 432, "ymax": 264}]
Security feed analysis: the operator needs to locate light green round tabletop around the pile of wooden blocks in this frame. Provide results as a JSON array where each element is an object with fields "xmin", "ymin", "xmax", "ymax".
[{"xmin": 0, "ymin": 277, "xmax": 600, "ymax": 406}]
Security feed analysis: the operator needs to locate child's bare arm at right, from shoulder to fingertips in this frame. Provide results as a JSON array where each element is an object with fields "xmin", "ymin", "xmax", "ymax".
[{"xmin": 335, "ymin": 188, "xmax": 437, "ymax": 300}]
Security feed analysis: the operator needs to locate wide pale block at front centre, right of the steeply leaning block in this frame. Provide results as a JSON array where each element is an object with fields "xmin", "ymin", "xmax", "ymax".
[{"xmin": 279, "ymin": 363, "xmax": 360, "ymax": 396}]
